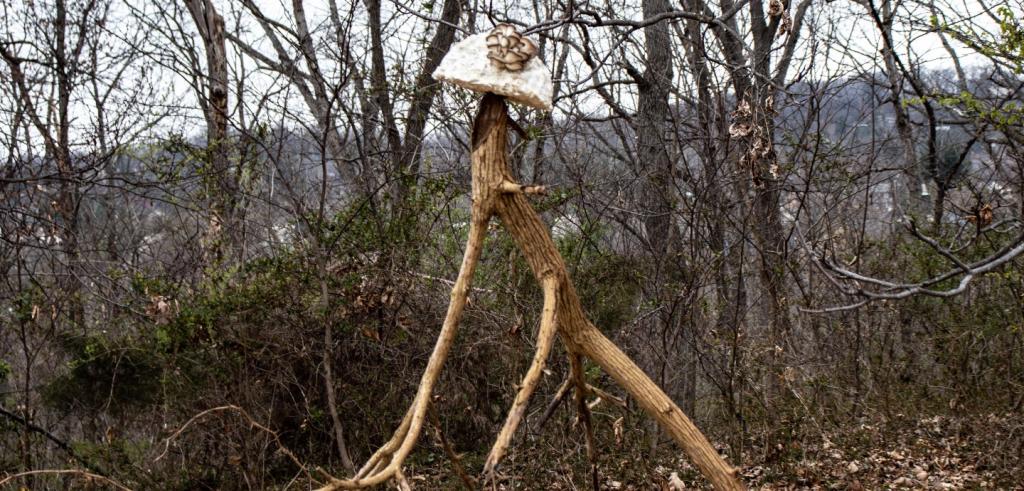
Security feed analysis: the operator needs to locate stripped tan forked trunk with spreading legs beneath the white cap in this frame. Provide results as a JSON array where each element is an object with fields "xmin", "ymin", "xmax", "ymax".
[{"xmin": 322, "ymin": 93, "xmax": 744, "ymax": 490}]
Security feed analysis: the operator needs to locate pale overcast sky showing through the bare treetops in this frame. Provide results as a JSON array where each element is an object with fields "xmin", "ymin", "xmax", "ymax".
[{"xmin": 4, "ymin": 0, "xmax": 1007, "ymax": 155}]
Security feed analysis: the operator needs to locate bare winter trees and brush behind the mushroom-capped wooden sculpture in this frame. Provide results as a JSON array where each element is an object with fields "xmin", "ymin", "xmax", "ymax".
[{"xmin": 0, "ymin": 0, "xmax": 1024, "ymax": 489}]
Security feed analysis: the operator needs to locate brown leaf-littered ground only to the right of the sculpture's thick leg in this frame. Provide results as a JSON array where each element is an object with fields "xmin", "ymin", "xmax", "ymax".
[{"xmin": 663, "ymin": 413, "xmax": 1024, "ymax": 490}]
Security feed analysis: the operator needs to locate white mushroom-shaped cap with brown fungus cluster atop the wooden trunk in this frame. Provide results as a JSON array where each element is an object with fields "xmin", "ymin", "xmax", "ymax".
[{"xmin": 433, "ymin": 24, "xmax": 554, "ymax": 111}]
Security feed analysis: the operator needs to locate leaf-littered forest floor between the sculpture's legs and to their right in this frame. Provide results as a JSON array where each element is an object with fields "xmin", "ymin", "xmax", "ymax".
[{"xmin": 403, "ymin": 413, "xmax": 1024, "ymax": 491}]
